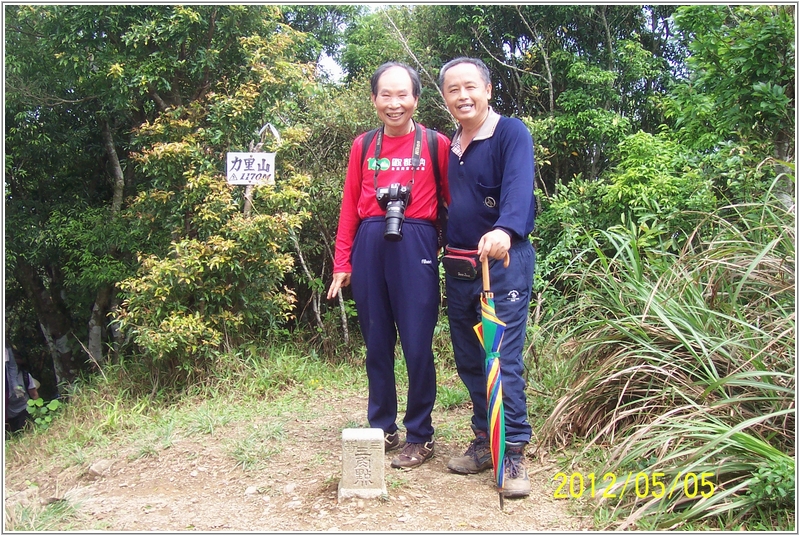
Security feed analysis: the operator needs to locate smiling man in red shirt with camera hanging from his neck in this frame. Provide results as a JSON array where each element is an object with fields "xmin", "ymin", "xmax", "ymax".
[{"xmin": 328, "ymin": 62, "xmax": 450, "ymax": 467}]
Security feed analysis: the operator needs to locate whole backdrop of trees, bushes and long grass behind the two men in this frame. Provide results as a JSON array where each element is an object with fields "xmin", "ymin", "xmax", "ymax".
[{"xmin": 4, "ymin": 4, "xmax": 796, "ymax": 528}]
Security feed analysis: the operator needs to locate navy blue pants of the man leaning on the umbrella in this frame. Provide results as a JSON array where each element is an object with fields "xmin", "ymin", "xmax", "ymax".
[{"xmin": 445, "ymin": 240, "xmax": 536, "ymax": 443}]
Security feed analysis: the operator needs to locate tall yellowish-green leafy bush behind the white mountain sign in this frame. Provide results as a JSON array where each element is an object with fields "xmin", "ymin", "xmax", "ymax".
[{"xmin": 116, "ymin": 25, "xmax": 311, "ymax": 381}]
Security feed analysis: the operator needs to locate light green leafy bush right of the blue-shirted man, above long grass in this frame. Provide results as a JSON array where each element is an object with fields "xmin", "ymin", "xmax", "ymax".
[{"xmin": 535, "ymin": 132, "xmax": 717, "ymax": 326}]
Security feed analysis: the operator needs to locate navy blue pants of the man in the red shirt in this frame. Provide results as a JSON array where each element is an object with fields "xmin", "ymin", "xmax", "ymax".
[{"xmin": 351, "ymin": 217, "xmax": 440, "ymax": 443}]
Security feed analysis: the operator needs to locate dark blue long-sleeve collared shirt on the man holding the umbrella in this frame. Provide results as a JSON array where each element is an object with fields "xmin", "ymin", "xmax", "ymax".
[{"xmin": 447, "ymin": 111, "xmax": 536, "ymax": 249}]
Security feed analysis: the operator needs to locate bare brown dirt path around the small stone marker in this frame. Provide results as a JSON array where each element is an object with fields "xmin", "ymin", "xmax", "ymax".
[{"xmin": 5, "ymin": 394, "xmax": 591, "ymax": 532}]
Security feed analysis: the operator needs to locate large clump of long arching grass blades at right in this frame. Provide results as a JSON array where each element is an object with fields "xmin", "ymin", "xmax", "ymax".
[{"xmin": 542, "ymin": 177, "xmax": 796, "ymax": 530}]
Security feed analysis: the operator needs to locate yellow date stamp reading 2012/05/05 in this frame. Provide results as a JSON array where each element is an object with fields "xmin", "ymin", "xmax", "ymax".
[{"xmin": 553, "ymin": 471, "xmax": 716, "ymax": 499}]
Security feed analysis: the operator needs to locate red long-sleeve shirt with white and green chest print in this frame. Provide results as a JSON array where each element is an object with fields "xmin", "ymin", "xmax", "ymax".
[{"xmin": 333, "ymin": 123, "xmax": 450, "ymax": 273}]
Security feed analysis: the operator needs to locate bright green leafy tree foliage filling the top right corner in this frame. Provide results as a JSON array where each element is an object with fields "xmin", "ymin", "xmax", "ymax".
[{"xmin": 669, "ymin": 6, "xmax": 795, "ymax": 158}]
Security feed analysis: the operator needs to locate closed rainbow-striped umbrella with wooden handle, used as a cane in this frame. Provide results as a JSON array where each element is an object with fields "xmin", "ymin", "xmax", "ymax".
[{"xmin": 475, "ymin": 255, "xmax": 509, "ymax": 510}]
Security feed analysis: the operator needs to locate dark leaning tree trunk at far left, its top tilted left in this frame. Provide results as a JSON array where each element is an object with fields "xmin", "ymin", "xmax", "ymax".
[{"xmin": 14, "ymin": 257, "xmax": 78, "ymax": 392}]
